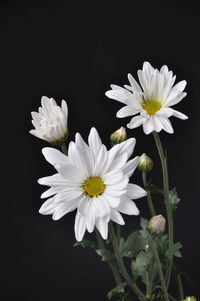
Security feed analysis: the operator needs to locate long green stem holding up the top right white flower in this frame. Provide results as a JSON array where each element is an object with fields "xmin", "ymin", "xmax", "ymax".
[{"xmin": 153, "ymin": 132, "xmax": 174, "ymax": 288}]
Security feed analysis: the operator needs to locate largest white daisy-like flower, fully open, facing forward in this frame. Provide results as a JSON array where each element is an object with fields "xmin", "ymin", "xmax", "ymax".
[{"xmin": 38, "ymin": 128, "xmax": 146, "ymax": 241}]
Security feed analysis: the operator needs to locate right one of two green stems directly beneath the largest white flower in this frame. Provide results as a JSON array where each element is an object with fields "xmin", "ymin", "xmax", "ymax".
[{"xmin": 109, "ymin": 222, "xmax": 147, "ymax": 301}]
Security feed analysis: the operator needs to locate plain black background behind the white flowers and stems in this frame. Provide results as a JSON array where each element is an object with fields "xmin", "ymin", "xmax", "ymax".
[{"xmin": 0, "ymin": 0, "xmax": 200, "ymax": 301}]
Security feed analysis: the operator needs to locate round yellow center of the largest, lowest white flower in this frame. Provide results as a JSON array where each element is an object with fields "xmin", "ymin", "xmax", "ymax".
[{"xmin": 82, "ymin": 177, "xmax": 106, "ymax": 197}]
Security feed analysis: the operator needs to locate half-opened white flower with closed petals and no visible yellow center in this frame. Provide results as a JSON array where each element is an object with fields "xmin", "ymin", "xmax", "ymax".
[{"xmin": 30, "ymin": 96, "xmax": 68, "ymax": 144}]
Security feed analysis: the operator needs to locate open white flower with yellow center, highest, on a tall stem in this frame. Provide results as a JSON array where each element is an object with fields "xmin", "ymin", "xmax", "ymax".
[{"xmin": 106, "ymin": 62, "xmax": 188, "ymax": 134}]
